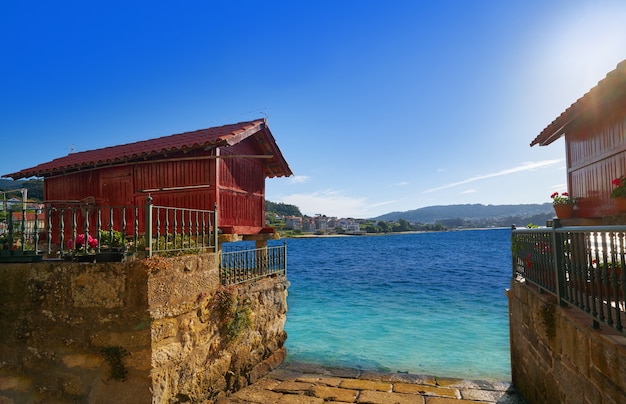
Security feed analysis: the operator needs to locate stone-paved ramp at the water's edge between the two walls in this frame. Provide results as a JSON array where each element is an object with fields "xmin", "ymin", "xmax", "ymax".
[{"xmin": 217, "ymin": 363, "xmax": 525, "ymax": 404}]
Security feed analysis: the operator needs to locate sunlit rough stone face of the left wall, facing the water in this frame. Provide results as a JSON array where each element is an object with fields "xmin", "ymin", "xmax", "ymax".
[{"xmin": 148, "ymin": 254, "xmax": 287, "ymax": 402}]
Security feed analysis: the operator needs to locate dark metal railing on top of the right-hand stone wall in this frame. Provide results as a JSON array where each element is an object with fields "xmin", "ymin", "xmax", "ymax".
[{"xmin": 511, "ymin": 221, "xmax": 626, "ymax": 333}]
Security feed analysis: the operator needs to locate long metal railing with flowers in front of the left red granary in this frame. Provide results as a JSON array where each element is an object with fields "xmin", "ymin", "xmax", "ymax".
[{"xmin": 0, "ymin": 197, "xmax": 218, "ymax": 261}]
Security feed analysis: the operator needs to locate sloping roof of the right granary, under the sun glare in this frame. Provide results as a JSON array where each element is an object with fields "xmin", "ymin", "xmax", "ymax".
[{"xmin": 530, "ymin": 60, "xmax": 626, "ymax": 147}]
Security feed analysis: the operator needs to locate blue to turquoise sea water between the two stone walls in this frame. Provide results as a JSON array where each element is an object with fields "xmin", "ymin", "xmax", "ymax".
[{"xmin": 276, "ymin": 229, "xmax": 511, "ymax": 381}]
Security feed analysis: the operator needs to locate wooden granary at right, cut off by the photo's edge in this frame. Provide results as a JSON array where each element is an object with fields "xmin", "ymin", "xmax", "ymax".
[{"xmin": 530, "ymin": 60, "xmax": 626, "ymax": 218}]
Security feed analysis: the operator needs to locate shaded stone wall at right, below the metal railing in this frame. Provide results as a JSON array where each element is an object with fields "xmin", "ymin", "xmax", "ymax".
[{"xmin": 507, "ymin": 280, "xmax": 626, "ymax": 404}]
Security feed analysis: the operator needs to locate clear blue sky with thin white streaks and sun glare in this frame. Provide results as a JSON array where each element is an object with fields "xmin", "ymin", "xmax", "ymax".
[{"xmin": 0, "ymin": 0, "xmax": 626, "ymax": 217}]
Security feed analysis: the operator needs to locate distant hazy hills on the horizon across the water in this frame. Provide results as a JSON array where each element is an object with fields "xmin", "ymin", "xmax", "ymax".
[{"xmin": 373, "ymin": 202, "xmax": 554, "ymax": 227}]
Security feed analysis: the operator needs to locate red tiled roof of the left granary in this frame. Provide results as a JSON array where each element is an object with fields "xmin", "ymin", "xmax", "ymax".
[{"xmin": 3, "ymin": 119, "xmax": 292, "ymax": 179}]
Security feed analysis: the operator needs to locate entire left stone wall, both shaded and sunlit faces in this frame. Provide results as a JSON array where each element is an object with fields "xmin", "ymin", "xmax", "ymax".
[{"xmin": 0, "ymin": 254, "xmax": 287, "ymax": 404}]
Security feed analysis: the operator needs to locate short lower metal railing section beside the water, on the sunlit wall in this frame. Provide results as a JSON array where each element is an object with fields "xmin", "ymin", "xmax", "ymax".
[{"xmin": 220, "ymin": 243, "xmax": 287, "ymax": 286}]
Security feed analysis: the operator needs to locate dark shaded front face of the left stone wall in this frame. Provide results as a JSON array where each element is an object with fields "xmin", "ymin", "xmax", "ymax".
[{"xmin": 0, "ymin": 261, "xmax": 151, "ymax": 403}]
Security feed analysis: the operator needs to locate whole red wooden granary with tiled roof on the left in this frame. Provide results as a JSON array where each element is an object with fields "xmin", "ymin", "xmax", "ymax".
[{"xmin": 4, "ymin": 119, "xmax": 292, "ymax": 235}]
